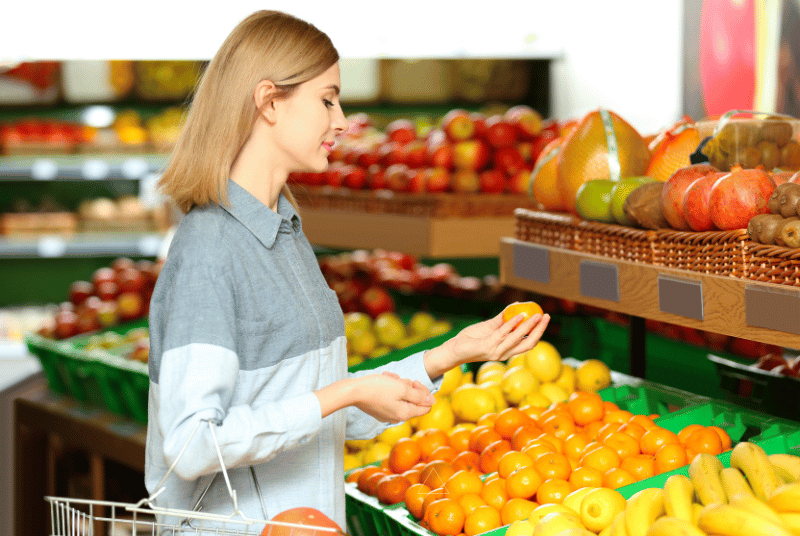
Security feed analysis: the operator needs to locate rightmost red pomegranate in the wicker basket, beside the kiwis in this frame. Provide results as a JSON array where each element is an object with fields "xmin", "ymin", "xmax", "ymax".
[{"xmin": 709, "ymin": 167, "xmax": 775, "ymax": 231}]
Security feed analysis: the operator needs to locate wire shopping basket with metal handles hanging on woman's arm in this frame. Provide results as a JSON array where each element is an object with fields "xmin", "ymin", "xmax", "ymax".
[{"xmin": 45, "ymin": 420, "xmax": 347, "ymax": 536}]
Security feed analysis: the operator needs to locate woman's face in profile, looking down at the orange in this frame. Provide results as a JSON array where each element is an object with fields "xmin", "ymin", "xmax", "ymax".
[{"xmin": 275, "ymin": 63, "xmax": 348, "ymax": 172}]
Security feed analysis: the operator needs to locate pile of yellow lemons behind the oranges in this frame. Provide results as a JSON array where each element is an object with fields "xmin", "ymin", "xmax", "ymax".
[{"xmin": 345, "ymin": 341, "xmax": 611, "ymax": 470}]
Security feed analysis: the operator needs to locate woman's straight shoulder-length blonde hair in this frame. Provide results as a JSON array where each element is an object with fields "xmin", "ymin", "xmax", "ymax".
[{"xmin": 159, "ymin": 10, "xmax": 339, "ymax": 213}]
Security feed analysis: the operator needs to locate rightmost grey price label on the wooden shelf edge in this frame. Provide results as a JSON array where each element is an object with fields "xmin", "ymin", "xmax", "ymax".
[{"xmin": 744, "ymin": 285, "xmax": 800, "ymax": 335}]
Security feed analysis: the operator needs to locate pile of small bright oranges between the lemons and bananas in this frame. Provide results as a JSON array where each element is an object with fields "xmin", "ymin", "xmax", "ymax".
[{"xmin": 348, "ymin": 392, "xmax": 731, "ymax": 536}]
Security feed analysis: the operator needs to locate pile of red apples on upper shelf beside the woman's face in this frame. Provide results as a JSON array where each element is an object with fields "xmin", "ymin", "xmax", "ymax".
[{"xmin": 290, "ymin": 105, "xmax": 560, "ymax": 194}]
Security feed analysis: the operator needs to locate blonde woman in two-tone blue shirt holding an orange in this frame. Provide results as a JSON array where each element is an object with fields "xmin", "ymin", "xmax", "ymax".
[{"xmin": 145, "ymin": 11, "xmax": 549, "ymax": 527}]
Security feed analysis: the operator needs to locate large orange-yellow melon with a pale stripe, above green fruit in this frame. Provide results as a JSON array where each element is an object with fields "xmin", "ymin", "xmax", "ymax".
[{"xmin": 558, "ymin": 109, "xmax": 650, "ymax": 213}]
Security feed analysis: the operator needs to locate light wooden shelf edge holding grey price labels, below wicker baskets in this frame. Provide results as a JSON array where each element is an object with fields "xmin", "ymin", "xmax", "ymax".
[{"xmin": 500, "ymin": 237, "xmax": 800, "ymax": 349}]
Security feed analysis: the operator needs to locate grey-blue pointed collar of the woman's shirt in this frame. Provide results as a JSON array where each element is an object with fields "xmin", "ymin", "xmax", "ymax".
[{"xmin": 222, "ymin": 180, "xmax": 300, "ymax": 248}]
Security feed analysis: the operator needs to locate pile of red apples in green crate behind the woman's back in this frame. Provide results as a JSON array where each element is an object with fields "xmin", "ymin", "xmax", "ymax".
[{"xmin": 38, "ymin": 257, "xmax": 163, "ymax": 339}]
